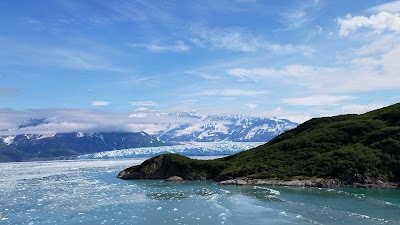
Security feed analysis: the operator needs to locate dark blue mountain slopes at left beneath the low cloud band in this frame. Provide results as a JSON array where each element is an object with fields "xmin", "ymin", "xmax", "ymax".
[{"xmin": 0, "ymin": 132, "xmax": 168, "ymax": 158}]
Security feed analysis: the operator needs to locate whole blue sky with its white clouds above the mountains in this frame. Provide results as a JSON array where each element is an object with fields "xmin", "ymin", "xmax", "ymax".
[{"xmin": 0, "ymin": 0, "xmax": 400, "ymax": 132}]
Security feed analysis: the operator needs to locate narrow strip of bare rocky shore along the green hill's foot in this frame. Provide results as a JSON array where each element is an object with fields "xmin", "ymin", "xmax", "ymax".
[{"xmin": 219, "ymin": 177, "xmax": 400, "ymax": 189}]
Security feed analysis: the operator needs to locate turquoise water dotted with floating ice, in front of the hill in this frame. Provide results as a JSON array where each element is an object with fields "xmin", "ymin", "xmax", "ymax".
[{"xmin": 0, "ymin": 159, "xmax": 400, "ymax": 225}]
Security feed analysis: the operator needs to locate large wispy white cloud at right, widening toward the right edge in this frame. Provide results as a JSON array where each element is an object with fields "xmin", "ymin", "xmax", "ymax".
[{"xmin": 226, "ymin": 40, "xmax": 400, "ymax": 94}]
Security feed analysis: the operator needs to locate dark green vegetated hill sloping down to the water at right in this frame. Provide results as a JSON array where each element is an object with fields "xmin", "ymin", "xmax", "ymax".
[{"xmin": 119, "ymin": 103, "xmax": 400, "ymax": 184}]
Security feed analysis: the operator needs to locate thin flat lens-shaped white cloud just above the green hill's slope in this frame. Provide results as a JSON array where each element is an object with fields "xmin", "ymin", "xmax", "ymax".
[{"xmin": 281, "ymin": 95, "xmax": 354, "ymax": 106}]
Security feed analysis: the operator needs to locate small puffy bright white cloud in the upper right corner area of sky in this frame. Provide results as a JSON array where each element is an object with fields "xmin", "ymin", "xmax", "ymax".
[{"xmin": 337, "ymin": 12, "xmax": 400, "ymax": 36}]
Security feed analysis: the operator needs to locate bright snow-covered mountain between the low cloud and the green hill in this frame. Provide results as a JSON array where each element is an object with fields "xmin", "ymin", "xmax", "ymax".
[{"xmin": 131, "ymin": 109, "xmax": 298, "ymax": 142}]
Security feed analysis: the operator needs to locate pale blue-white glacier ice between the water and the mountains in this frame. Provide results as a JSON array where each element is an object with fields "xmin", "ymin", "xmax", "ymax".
[{"xmin": 78, "ymin": 142, "xmax": 263, "ymax": 159}]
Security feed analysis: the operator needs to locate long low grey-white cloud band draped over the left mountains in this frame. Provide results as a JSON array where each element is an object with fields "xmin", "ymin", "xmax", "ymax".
[{"xmin": 0, "ymin": 108, "xmax": 200, "ymax": 135}]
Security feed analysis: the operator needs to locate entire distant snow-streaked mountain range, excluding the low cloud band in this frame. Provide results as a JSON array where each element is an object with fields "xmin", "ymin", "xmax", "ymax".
[{"xmin": 0, "ymin": 108, "xmax": 297, "ymax": 161}]
